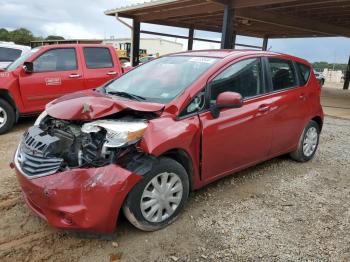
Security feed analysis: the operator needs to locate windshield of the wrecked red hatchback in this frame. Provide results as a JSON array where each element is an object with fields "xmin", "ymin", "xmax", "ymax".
[{"xmin": 106, "ymin": 56, "xmax": 219, "ymax": 104}]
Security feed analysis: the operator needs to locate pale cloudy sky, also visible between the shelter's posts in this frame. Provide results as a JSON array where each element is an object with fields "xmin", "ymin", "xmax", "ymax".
[{"xmin": 0, "ymin": 0, "xmax": 350, "ymax": 63}]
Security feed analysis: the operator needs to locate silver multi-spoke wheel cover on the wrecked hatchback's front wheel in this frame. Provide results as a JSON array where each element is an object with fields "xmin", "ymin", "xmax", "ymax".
[{"xmin": 140, "ymin": 172, "xmax": 183, "ymax": 223}]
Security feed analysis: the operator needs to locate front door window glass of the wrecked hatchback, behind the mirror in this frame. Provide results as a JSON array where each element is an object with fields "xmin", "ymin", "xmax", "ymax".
[{"xmin": 210, "ymin": 58, "xmax": 264, "ymax": 103}]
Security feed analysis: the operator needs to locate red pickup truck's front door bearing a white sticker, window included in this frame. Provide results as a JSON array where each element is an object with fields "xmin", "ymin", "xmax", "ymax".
[{"xmin": 19, "ymin": 47, "xmax": 85, "ymax": 112}]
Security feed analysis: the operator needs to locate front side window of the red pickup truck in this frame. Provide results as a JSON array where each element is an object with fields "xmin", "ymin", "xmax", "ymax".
[{"xmin": 33, "ymin": 48, "xmax": 78, "ymax": 72}]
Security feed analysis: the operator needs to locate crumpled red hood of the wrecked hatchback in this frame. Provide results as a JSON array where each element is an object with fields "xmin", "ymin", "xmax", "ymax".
[{"xmin": 46, "ymin": 90, "xmax": 164, "ymax": 120}]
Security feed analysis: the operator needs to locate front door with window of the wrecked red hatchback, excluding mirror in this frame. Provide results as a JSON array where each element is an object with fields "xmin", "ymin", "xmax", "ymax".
[{"xmin": 200, "ymin": 58, "xmax": 272, "ymax": 182}]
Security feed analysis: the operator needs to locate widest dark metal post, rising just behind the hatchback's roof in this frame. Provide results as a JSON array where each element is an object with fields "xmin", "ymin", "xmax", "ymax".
[{"xmin": 221, "ymin": 5, "xmax": 234, "ymax": 49}]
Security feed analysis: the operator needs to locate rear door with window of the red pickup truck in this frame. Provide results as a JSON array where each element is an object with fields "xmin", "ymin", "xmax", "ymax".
[{"xmin": 82, "ymin": 46, "xmax": 121, "ymax": 88}]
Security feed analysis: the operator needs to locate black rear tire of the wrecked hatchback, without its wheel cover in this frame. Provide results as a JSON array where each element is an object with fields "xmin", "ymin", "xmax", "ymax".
[{"xmin": 290, "ymin": 120, "xmax": 320, "ymax": 162}]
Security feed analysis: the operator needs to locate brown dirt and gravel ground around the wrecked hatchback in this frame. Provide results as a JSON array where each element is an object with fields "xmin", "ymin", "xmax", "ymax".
[{"xmin": 0, "ymin": 117, "xmax": 350, "ymax": 261}]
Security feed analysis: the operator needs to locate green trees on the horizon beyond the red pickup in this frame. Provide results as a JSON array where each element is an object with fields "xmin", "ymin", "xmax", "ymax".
[{"xmin": 0, "ymin": 28, "xmax": 64, "ymax": 45}]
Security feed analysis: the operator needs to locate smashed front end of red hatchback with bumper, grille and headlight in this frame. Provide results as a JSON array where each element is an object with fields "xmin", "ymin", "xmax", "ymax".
[{"xmin": 14, "ymin": 109, "xmax": 159, "ymax": 233}]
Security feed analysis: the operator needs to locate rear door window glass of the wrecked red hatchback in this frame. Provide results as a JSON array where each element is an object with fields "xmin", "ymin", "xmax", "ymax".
[{"xmin": 269, "ymin": 58, "xmax": 297, "ymax": 91}]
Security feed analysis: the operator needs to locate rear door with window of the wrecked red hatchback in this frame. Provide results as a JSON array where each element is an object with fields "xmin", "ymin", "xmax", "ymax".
[{"xmin": 267, "ymin": 58, "xmax": 309, "ymax": 156}]
